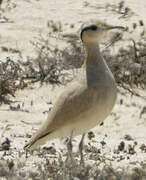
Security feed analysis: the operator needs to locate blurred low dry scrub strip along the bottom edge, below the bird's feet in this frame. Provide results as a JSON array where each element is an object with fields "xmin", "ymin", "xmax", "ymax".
[{"xmin": 0, "ymin": 159, "xmax": 146, "ymax": 180}]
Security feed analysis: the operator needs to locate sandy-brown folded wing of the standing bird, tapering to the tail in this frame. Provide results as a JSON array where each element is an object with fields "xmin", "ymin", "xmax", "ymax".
[{"xmin": 26, "ymin": 82, "xmax": 92, "ymax": 149}]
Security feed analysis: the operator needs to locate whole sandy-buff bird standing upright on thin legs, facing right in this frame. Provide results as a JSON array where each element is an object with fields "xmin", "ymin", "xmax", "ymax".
[{"xmin": 24, "ymin": 20, "xmax": 124, "ymax": 164}]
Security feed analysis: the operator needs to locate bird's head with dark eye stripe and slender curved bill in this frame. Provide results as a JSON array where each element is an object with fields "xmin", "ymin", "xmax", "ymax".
[{"xmin": 80, "ymin": 21, "xmax": 125, "ymax": 43}]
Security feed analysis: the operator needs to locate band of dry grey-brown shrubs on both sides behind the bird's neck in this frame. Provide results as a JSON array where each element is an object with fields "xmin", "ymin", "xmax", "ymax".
[{"xmin": 0, "ymin": 23, "xmax": 146, "ymax": 102}]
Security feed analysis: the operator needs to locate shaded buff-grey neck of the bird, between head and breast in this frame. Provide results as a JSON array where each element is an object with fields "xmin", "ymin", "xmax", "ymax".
[{"xmin": 83, "ymin": 43, "xmax": 114, "ymax": 86}]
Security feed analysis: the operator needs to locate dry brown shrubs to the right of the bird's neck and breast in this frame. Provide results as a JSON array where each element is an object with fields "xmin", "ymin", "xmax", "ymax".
[{"xmin": 104, "ymin": 37, "xmax": 146, "ymax": 88}]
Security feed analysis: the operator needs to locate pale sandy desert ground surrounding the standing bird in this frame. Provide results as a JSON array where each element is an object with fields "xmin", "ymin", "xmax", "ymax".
[{"xmin": 0, "ymin": 0, "xmax": 146, "ymax": 180}]
